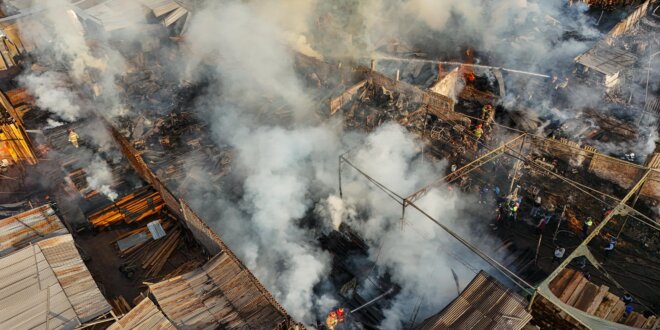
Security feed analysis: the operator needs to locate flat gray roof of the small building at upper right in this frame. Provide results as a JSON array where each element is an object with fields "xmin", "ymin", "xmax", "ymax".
[{"xmin": 575, "ymin": 42, "xmax": 637, "ymax": 75}]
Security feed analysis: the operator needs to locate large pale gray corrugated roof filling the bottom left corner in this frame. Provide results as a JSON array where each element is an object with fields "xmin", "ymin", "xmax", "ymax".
[{"xmin": 0, "ymin": 235, "xmax": 111, "ymax": 329}]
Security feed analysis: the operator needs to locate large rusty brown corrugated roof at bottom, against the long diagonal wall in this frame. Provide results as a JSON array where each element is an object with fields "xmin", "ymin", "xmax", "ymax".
[{"xmin": 149, "ymin": 252, "xmax": 284, "ymax": 329}]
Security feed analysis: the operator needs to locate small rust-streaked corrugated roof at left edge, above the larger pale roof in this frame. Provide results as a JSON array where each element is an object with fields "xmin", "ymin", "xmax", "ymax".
[{"xmin": 0, "ymin": 205, "xmax": 68, "ymax": 256}]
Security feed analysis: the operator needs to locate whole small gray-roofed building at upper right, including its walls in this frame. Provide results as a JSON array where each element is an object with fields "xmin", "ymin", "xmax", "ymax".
[{"xmin": 575, "ymin": 42, "xmax": 637, "ymax": 94}]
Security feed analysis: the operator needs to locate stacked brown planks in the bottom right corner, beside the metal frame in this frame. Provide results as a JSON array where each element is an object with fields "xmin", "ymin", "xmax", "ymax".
[{"xmin": 550, "ymin": 269, "xmax": 660, "ymax": 329}]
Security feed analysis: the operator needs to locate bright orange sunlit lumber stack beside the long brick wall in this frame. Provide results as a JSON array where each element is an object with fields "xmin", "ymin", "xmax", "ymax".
[{"xmin": 88, "ymin": 187, "xmax": 165, "ymax": 227}]
